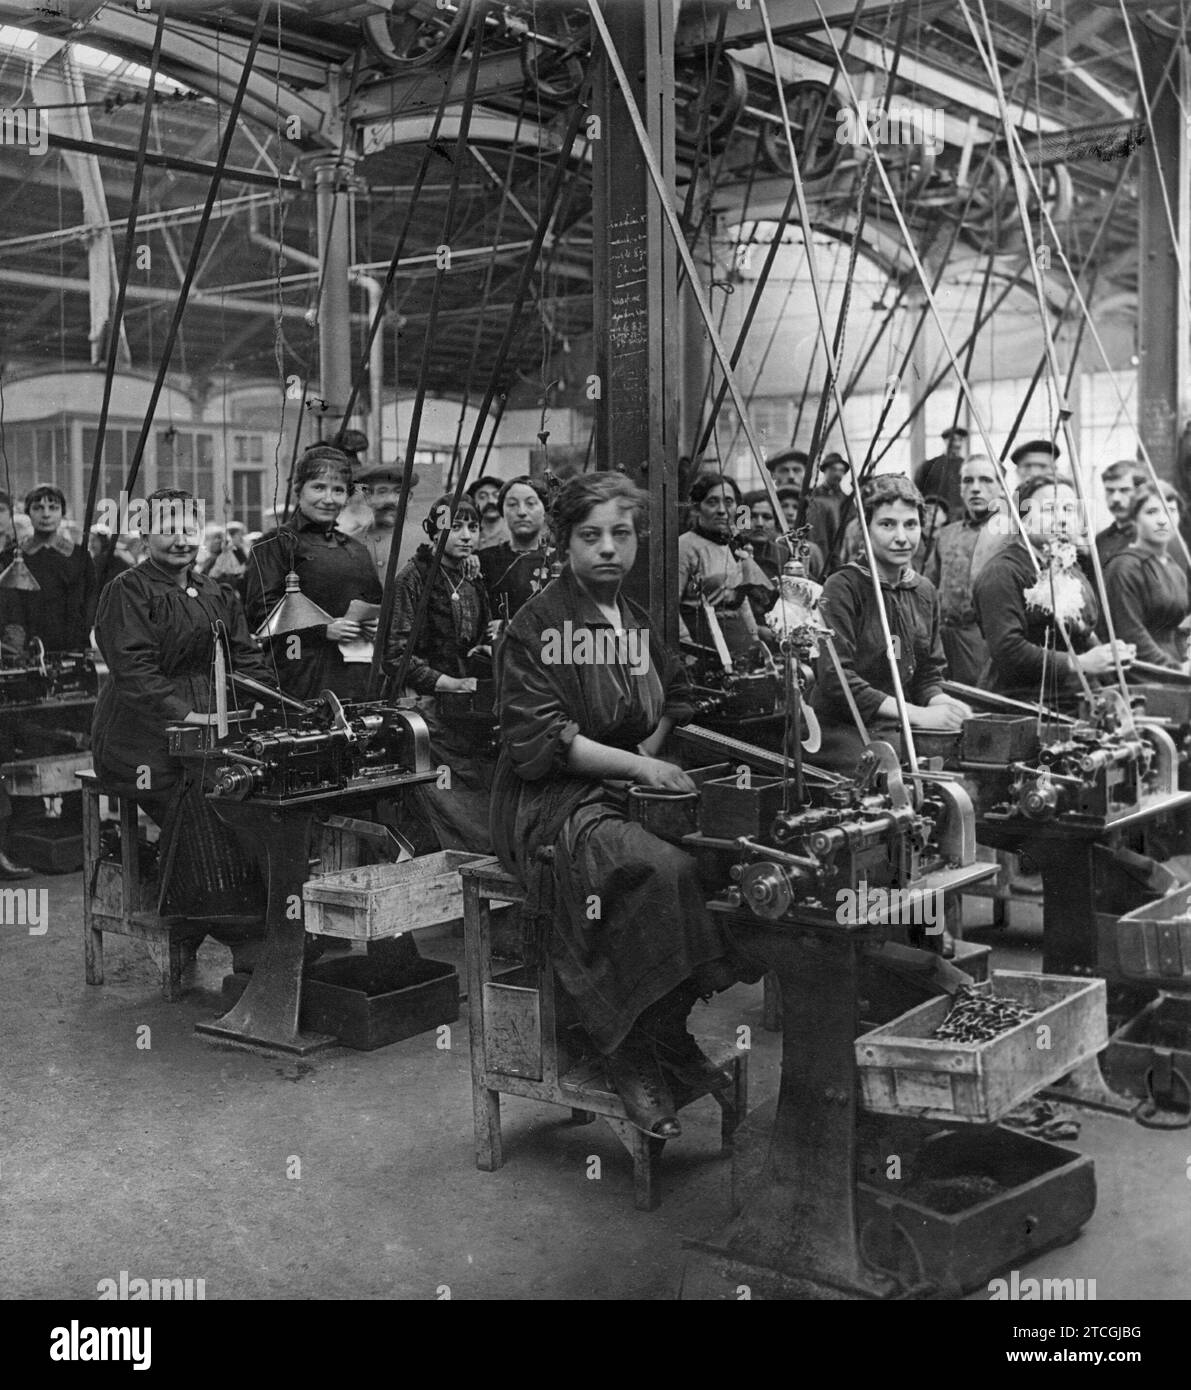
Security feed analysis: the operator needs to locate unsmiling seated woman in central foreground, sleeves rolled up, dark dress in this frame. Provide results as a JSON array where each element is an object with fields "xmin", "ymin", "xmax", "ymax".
[{"xmin": 492, "ymin": 473, "xmax": 756, "ymax": 1138}]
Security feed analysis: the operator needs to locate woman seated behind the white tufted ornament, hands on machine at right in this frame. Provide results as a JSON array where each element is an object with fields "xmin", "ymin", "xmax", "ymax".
[{"xmin": 971, "ymin": 473, "xmax": 1134, "ymax": 712}]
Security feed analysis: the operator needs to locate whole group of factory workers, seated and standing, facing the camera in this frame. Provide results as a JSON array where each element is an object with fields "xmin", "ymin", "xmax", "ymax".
[{"xmin": 0, "ymin": 432, "xmax": 1191, "ymax": 1138}]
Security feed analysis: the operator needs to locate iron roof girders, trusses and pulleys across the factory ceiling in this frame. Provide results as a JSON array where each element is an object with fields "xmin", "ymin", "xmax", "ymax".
[{"xmin": 0, "ymin": 0, "xmax": 1161, "ymax": 395}]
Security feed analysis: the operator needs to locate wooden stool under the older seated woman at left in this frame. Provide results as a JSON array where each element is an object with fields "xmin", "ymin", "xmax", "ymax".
[{"xmin": 76, "ymin": 771, "xmax": 204, "ymax": 1004}]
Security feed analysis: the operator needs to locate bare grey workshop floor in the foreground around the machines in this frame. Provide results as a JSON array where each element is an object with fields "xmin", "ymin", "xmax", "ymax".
[{"xmin": 0, "ymin": 874, "xmax": 1191, "ymax": 1300}]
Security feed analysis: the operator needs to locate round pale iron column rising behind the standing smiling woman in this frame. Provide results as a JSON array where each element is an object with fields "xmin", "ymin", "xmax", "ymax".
[{"xmin": 310, "ymin": 156, "xmax": 354, "ymax": 438}]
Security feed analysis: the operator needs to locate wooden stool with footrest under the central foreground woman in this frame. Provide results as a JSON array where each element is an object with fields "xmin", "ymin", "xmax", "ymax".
[{"xmin": 459, "ymin": 859, "xmax": 748, "ymax": 1211}]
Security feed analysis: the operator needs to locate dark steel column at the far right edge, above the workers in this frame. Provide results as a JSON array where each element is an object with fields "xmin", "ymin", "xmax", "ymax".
[{"xmin": 1134, "ymin": 24, "xmax": 1191, "ymax": 481}]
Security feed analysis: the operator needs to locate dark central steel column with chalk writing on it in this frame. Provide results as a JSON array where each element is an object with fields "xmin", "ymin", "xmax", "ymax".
[{"xmin": 591, "ymin": 0, "xmax": 681, "ymax": 644}]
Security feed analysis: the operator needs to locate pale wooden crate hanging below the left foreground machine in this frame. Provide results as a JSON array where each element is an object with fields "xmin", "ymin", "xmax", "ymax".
[{"xmin": 302, "ymin": 849, "xmax": 491, "ymax": 941}]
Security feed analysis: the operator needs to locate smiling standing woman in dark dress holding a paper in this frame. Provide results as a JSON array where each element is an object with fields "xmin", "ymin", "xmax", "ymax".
[{"xmin": 245, "ymin": 445, "xmax": 381, "ymax": 701}]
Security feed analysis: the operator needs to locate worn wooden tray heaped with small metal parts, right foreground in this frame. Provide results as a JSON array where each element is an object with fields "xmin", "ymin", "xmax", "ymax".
[{"xmin": 856, "ymin": 970, "xmax": 1108, "ymax": 1125}]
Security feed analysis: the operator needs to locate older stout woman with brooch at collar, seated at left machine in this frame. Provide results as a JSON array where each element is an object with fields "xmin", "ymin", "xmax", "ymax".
[{"xmin": 92, "ymin": 488, "xmax": 274, "ymax": 935}]
